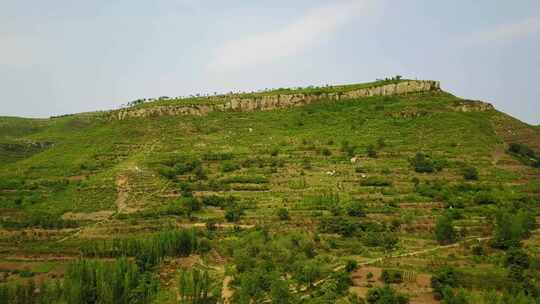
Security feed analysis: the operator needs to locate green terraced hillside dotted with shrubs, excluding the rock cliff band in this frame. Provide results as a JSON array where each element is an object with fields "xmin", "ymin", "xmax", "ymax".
[{"xmin": 0, "ymin": 81, "xmax": 540, "ymax": 303}]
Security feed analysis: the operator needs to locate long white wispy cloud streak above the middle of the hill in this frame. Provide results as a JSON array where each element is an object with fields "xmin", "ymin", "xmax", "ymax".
[{"xmin": 211, "ymin": 0, "xmax": 371, "ymax": 69}]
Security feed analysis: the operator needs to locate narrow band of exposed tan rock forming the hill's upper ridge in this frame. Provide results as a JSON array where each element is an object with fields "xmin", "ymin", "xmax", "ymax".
[{"xmin": 110, "ymin": 80, "xmax": 440, "ymax": 120}]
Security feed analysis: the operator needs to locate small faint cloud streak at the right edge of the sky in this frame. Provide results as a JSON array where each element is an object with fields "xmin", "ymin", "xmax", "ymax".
[{"xmin": 465, "ymin": 16, "xmax": 540, "ymax": 45}]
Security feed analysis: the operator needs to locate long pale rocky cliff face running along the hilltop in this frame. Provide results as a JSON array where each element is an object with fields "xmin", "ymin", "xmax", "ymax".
[{"xmin": 111, "ymin": 80, "xmax": 440, "ymax": 120}]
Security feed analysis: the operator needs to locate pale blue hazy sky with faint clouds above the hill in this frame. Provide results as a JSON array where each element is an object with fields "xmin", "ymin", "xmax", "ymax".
[{"xmin": 0, "ymin": 0, "xmax": 540, "ymax": 124}]
